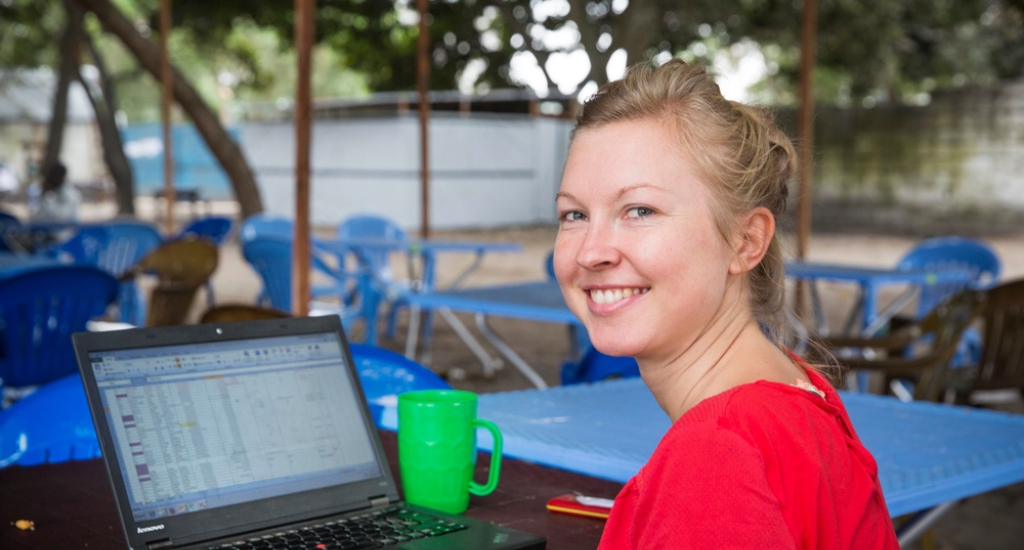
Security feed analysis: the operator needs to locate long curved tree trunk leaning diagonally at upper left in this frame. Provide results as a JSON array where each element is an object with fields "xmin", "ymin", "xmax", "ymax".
[{"xmin": 76, "ymin": 0, "xmax": 263, "ymax": 216}]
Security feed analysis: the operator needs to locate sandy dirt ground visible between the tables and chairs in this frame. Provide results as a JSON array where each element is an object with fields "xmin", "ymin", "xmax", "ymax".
[{"xmin": 88, "ymin": 205, "xmax": 1024, "ymax": 550}]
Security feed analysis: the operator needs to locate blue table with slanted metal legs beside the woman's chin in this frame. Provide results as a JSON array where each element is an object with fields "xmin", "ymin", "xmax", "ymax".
[{"xmin": 406, "ymin": 281, "xmax": 585, "ymax": 388}]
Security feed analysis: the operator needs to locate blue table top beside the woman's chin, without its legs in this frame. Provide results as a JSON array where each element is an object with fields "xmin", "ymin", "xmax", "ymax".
[{"xmin": 407, "ymin": 281, "xmax": 582, "ymax": 325}]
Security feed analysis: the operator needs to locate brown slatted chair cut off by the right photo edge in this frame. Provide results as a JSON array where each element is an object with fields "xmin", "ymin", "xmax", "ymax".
[{"xmin": 972, "ymin": 279, "xmax": 1024, "ymax": 399}]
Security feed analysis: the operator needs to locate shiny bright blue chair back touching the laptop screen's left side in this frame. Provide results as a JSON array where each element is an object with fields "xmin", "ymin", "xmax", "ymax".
[{"xmin": 0, "ymin": 374, "xmax": 100, "ymax": 468}]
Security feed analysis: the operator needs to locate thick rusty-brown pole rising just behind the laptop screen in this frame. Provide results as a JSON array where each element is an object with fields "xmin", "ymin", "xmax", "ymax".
[{"xmin": 292, "ymin": 0, "xmax": 316, "ymax": 316}]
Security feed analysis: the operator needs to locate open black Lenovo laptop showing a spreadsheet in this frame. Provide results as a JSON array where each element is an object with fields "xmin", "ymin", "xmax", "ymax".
[{"xmin": 73, "ymin": 315, "xmax": 545, "ymax": 550}]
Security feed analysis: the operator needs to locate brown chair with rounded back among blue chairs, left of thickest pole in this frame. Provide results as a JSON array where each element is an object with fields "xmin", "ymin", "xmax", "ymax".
[{"xmin": 126, "ymin": 237, "xmax": 217, "ymax": 327}]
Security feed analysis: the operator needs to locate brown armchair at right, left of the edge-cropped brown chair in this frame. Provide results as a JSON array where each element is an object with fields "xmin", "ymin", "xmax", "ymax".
[{"xmin": 819, "ymin": 290, "xmax": 985, "ymax": 401}]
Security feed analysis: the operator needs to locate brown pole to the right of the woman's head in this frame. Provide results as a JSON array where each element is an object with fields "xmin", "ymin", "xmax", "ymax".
[{"xmin": 796, "ymin": 0, "xmax": 818, "ymax": 314}]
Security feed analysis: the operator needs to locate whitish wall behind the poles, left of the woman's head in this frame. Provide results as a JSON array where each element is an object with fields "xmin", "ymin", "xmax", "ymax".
[{"xmin": 241, "ymin": 114, "xmax": 571, "ymax": 228}]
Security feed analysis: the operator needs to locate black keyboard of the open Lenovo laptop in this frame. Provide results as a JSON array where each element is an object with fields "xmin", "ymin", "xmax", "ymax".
[{"xmin": 210, "ymin": 507, "xmax": 466, "ymax": 550}]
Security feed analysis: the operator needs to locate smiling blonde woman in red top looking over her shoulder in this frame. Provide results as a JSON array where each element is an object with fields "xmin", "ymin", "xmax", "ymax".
[{"xmin": 555, "ymin": 60, "xmax": 898, "ymax": 549}]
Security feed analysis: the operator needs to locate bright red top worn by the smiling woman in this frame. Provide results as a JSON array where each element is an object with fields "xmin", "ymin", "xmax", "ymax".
[{"xmin": 599, "ymin": 370, "xmax": 899, "ymax": 550}]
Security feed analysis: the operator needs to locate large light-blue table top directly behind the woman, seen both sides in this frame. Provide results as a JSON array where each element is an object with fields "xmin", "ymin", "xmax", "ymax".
[{"xmin": 383, "ymin": 378, "xmax": 1024, "ymax": 516}]
